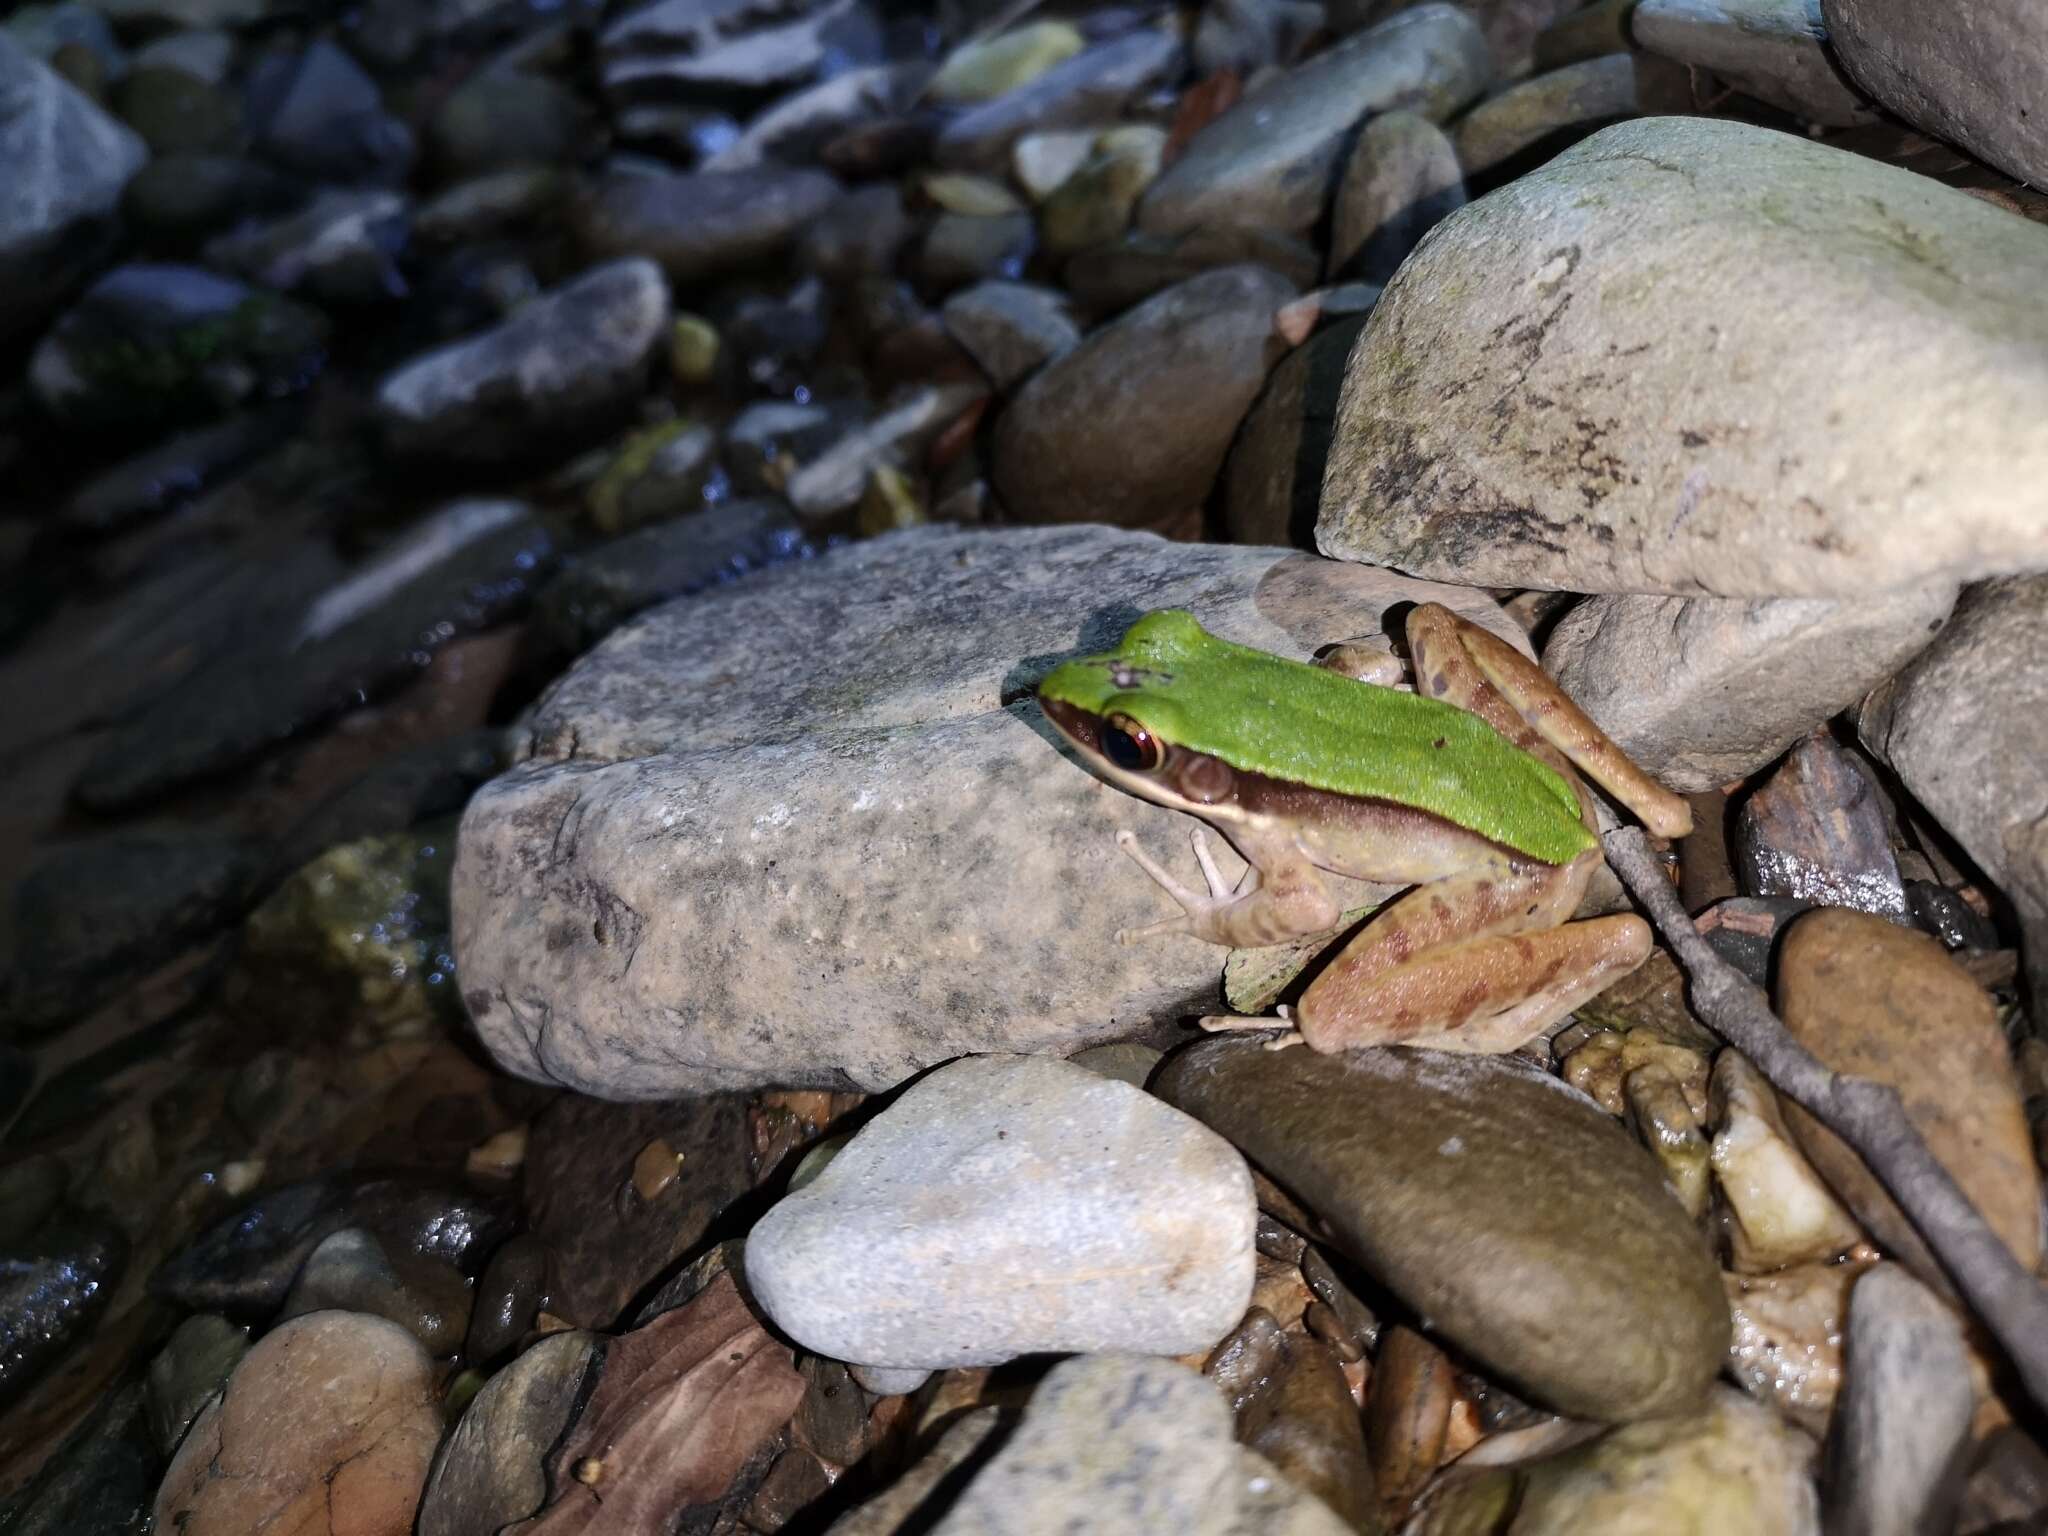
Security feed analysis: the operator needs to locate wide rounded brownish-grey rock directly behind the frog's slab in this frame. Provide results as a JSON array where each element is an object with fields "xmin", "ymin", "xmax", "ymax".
[{"xmin": 991, "ymin": 266, "xmax": 1294, "ymax": 540}]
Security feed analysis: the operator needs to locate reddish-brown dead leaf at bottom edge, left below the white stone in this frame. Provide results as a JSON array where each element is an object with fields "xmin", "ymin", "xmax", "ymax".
[{"xmin": 510, "ymin": 1272, "xmax": 803, "ymax": 1536}]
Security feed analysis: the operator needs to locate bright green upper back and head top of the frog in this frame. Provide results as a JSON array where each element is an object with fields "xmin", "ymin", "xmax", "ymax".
[{"xmin": 1038, "ymin": 608, "xmax": 1593, "ymax": 864}]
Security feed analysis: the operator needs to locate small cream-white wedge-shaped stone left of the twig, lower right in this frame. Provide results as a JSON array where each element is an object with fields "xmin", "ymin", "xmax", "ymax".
[{"xmin": 1712, "ymin": 1051, "xmax": 1864, "ymax": 1274}]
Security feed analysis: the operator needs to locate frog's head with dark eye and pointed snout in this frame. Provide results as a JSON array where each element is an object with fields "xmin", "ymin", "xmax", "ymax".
[{"xmin": 1038, "ymin": 608, "xmax": 1237, "ymax": 811}]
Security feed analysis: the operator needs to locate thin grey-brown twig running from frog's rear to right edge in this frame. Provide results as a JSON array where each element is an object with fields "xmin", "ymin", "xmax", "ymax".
[{"xmin": 1608, "ymin": 827, "xmax": 2048, "ymax": 1407}]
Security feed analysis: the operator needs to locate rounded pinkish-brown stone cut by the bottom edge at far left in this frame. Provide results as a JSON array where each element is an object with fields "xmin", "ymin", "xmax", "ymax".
[{"xmin": 156, "ymin": 1313, "xmax": 440, "ymax": 1536}]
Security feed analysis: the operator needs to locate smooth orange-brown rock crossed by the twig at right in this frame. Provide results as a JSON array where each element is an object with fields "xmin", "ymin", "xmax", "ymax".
[{"xmin": 1778, "ymin": 907, "xmax": 2042, "ymax": 1294}]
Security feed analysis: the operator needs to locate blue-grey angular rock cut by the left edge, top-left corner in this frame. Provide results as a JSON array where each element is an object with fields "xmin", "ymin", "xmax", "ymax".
[{"xmin": 0, "ymin": 31, "xmax": 150, "ymax": 340}]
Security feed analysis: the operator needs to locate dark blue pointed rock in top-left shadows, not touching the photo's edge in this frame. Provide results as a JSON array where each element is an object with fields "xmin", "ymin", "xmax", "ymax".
[{"xmin": 248, "ymin": 39, "xmax": 412, "ymax": 182}]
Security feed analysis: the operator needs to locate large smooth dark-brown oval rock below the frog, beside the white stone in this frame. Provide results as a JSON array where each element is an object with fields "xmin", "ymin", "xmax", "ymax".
[{"xmin": 1153, "ymin": 1038, "xmax": 1729, "ymax": 1421}]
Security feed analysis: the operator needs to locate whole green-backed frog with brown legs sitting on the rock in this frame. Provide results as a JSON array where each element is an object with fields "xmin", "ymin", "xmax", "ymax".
[{"xmin": 1036, "ymin": 602, "xmax": 1692, "ymax": 1055}]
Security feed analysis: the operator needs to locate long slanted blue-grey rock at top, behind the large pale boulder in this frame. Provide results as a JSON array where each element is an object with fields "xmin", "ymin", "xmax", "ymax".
[{"xmin": 1139, "ymin": 4, "xmax": 1489, "ymax": 233}]
